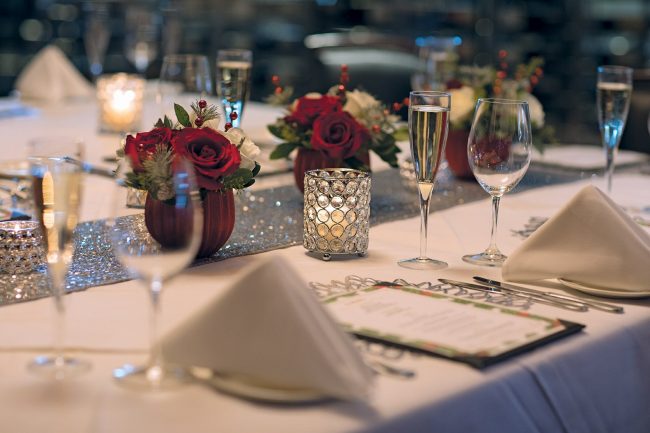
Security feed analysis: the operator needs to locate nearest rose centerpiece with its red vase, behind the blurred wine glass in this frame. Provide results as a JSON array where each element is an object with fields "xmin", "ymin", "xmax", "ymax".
[{"xmin": 118, "ymin": 100, "xmax": 260, "ymax": 257}]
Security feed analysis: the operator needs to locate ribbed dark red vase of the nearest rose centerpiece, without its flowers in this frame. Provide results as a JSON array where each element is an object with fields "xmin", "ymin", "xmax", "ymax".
[{"xmin": 144, "ymin": 190, "xmax": 235, "ymax": 258}]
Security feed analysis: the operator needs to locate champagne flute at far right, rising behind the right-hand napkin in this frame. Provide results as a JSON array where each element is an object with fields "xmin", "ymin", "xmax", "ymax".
[{"xmin": 597, "ymin": 66, "xmax": 632, "ymax": 194}]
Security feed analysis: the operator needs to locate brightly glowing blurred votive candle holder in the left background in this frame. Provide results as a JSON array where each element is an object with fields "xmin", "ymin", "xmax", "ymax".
[{"xmin": 97, "ymin": 73, "xmax": 145, "ymax": 133}]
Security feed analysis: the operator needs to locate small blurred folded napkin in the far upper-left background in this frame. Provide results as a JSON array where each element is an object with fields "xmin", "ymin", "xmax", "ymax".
[{"xmin": 16, "ymin": 45, "xmax": 94, "ymax": 102}]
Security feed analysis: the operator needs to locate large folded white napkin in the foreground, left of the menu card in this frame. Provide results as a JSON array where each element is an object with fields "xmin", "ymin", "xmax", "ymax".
[{"xmin": 162, "ymin": 257, "xmax": 373, "ymax": 400}]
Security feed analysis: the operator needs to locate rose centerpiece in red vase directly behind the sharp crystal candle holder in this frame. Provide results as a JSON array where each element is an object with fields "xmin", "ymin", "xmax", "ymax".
[{"xmin": 268, "ymin": 65, "xmax": 402, "ymax": 191}]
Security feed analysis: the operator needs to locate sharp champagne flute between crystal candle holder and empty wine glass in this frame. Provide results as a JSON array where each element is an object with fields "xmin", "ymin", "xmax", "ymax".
[{"xmin": 398, "ymin": 91, "xmax": 451, "ymax": 269}]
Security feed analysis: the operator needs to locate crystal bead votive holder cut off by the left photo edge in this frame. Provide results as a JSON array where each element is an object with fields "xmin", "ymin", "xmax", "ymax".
[{"xmin": 0, "ymin": 221, "xmax": 45, "ymax": 275}]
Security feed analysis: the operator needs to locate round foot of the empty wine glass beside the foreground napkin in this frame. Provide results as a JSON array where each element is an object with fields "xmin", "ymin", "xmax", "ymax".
[{"xmin": 113, "ymin": 364, "xmax": 190, "ymax": 391}]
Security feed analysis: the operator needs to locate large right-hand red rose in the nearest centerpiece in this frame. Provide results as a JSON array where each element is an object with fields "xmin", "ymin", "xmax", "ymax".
[{"xmin": 172, "ymin": 128, "xmax": 241, "ymax": 191}]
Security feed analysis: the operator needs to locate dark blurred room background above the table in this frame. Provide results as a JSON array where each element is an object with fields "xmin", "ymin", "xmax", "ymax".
[{"xmin": 0, "ymin": 0, "xmax": 650, "ymax": 152}]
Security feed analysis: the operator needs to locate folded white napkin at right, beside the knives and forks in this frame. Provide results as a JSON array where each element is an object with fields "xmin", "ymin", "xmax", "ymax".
[{"xmin": 502, "ymin": 185, "xmax": 650, "ymax": 291}]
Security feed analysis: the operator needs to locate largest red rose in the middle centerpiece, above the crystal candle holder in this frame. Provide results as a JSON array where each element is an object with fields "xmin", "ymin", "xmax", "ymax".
[{"xmin": 311, "ymin": 111, "xmax": 370, "ymax": 159}]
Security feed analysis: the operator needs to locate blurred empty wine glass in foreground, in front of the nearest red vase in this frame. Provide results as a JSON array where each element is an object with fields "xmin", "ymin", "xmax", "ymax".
[{"xmin": 107, "ymin": 157, "xmax": 203, "ymax": 391}]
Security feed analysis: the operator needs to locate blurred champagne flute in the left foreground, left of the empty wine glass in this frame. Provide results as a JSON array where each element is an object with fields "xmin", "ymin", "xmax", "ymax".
[{"xmin": 27, "ymin": 137, "xmax": 90, "ymax": 380}]
